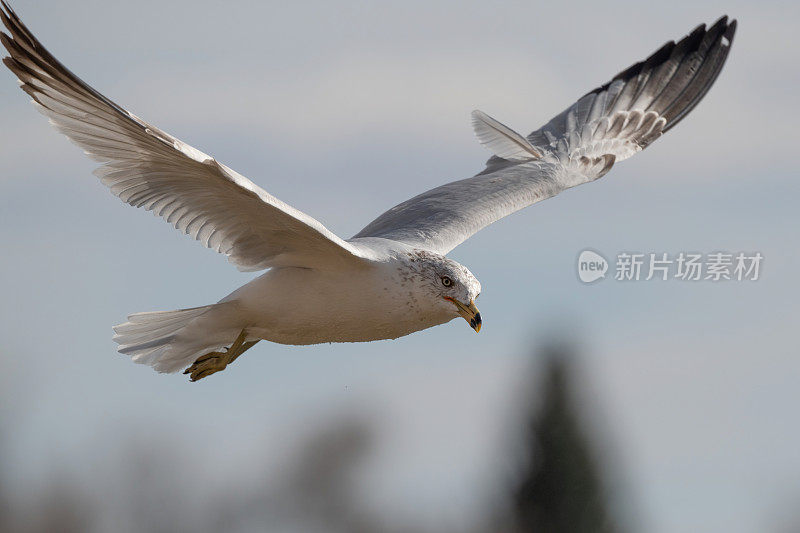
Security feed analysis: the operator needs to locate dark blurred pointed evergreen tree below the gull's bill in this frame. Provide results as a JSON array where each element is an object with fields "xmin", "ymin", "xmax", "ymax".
[{"xmin": 511, "ymin": 344, "xmax": 619, "ymax": 533}]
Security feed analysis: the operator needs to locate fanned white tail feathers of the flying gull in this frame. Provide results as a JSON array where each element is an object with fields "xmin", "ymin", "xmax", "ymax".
[{"xmin": 114, "ymin": 304, "xmax": 224, "ymax": 372}]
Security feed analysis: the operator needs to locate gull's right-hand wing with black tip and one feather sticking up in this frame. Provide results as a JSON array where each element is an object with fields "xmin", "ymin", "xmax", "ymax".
[{"xmin": 354, "ymin": 17, "xmax": 736, "ymax": 254}]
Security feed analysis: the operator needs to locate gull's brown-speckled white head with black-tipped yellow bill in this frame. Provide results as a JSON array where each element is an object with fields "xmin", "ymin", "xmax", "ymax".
[{"xmin": 400, "ymin": 250, "xmax": 481, "ymax": 332}]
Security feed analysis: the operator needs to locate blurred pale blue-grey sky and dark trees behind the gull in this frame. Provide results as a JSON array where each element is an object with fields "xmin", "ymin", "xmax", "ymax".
[{"xmin": 0, "ymin": 0, "xmax": 800, "ymax": 533}]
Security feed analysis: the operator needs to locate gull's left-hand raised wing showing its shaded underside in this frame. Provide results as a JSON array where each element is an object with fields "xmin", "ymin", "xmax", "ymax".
[{"xmin": 0, "ymin": 1, "xmax": 368, "ymax": 270}]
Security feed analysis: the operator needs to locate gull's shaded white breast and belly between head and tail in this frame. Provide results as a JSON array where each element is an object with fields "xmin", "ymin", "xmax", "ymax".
[{"xmin": 225, "ymin": 261, "xmax": 453, "ymax": 344}]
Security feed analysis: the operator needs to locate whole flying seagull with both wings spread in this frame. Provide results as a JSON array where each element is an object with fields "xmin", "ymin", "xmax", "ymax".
[{"xmin": 0, "ymin": 0, "xmax": 736, "ymax": 381}]
